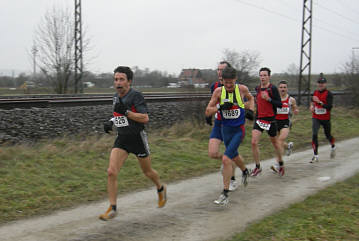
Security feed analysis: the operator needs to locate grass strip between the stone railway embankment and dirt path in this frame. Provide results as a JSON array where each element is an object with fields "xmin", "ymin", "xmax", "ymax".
[{"xmin": 0, "ymin": 108, "xmax": 359, "ymax": 230}]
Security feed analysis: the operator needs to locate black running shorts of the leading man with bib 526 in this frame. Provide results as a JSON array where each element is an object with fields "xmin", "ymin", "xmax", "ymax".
[{"xmin": 113, "ymin": 130, "xmax": 150, "ymax": 157}]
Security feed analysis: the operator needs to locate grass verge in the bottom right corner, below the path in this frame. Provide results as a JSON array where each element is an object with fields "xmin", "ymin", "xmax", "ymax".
[{"xmin": 228, "ymin": 174, "xmax": 359, "ymax": 241}]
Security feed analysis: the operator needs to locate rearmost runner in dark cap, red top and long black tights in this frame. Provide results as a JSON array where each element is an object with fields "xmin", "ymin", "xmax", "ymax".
[{"xmin": 310, "ymin": 73, "xmax": 336, "ymax": 163}]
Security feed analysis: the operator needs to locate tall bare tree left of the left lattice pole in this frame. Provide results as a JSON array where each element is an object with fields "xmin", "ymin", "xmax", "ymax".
[{"xmin": 34, "ymin": 7, "xmax": 74, "ymax": 94}]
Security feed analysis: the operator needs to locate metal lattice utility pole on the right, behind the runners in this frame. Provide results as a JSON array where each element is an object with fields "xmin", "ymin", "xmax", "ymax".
[{"xmin": 298, "ymin": 0, "xmax": 313, "ymax": 107}]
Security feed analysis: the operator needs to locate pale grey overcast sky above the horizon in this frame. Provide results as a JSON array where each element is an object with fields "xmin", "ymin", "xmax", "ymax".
[{"xmin": 0, "ymin": 0, "xmax": 359, "ymax": 74}]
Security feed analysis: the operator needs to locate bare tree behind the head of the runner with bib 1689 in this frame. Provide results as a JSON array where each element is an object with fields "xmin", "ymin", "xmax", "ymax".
[{"xmin": 223, "ymin": 49, "xmax": 260, "ymax": 83}]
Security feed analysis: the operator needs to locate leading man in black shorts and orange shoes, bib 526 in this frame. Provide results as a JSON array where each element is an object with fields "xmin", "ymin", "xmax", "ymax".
[{"xmin": 99, "ymin": 66, "xmax": 167, "ymax": 221}]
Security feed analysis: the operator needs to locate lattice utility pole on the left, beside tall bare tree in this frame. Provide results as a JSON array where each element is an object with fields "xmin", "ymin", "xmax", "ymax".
[{"xmin": 75, "ymin": 0, "xmax": 84, "ymax": 93}]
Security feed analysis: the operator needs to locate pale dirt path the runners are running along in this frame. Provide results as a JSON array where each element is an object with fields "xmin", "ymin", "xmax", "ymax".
[{"xmin": 0, "ymin": 138, "xmax": 359, "ymax": 241}]
